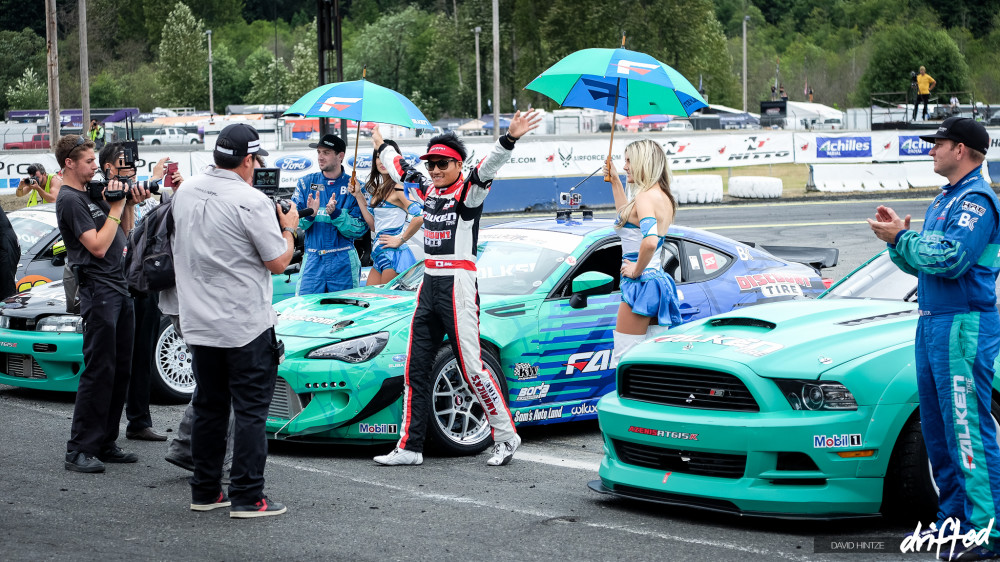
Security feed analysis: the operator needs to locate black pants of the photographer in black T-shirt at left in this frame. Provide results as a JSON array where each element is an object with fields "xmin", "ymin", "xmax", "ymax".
[{"xmin": 66, "ymin": 281, "xmax": 135, "ymax": 455}]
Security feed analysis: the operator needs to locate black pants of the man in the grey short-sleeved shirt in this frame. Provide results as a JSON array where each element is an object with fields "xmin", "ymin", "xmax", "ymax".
[{"xmin": 190, "ymin": 328, "xmax": 278, "ymax": 505}]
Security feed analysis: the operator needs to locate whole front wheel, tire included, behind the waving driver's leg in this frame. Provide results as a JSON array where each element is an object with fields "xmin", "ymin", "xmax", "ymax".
[{"xmin": 427, "ymin": 345, "xmax": 509, "ymax": 456}]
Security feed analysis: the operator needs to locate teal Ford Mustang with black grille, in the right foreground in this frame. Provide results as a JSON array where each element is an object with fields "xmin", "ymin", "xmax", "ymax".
[{"xmin": 590, "ymin": 252, "xmax": 1000, "ymax": 521}]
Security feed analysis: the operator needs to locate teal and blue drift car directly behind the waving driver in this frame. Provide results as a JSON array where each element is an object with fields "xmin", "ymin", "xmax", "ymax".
[{"xmin": 267, "ymin": 217, "xmax": 837, "ymax": 454}]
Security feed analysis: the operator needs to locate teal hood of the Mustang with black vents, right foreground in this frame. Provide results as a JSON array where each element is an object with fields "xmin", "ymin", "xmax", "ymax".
[{"xmin": 623, "ymin": 299, "xmax": 917, "ymax": 379}]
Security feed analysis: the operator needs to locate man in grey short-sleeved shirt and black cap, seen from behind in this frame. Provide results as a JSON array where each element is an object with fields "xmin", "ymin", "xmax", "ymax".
[{"xmin": 172, "ymin": 123, "xmax": 299, "ymax": 518}]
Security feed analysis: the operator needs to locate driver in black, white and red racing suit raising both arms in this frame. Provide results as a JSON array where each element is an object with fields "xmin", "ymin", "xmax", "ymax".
[{"xmin": 372, "ymin": 111, "xmax": 541, "ymax": 466}]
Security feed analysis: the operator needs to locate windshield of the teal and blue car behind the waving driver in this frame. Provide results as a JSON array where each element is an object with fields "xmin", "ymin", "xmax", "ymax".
[{"xmin": 387, "ymin": 235, "xmax": 570, "ymax": 295}]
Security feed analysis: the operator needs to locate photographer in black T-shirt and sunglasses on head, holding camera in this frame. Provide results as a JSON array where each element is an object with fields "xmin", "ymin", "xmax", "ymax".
[{"xmin": 55, "ymin": 135, "xmax": 149, "ymax": 472}]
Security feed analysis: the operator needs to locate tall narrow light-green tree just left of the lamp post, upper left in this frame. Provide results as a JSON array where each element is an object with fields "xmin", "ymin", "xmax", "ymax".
[{"xmin": 159, "ymin": 2, "xmax": 208, "ymax": 107}]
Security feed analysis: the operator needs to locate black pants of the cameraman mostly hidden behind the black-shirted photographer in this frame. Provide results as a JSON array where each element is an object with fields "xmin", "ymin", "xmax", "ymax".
[{"xmin": 125, "ymin": 292, "xmax": 160, "ymax": 432}]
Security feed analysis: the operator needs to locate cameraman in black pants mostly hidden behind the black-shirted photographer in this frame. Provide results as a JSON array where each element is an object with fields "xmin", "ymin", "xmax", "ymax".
[{"xmin": 94, "ymin": 142, "xmax": 167, "ymax": 441}]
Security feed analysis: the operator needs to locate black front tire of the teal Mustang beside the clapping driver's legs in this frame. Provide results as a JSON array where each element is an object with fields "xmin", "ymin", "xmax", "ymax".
[{"xmin": 882, "ymin": 400, "xmax": 1000, "ymax": 524}]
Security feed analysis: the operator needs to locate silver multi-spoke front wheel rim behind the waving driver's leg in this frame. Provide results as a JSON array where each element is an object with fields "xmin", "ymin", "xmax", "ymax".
[{"xmin": 432, "ymin": 358, "xmax": 493, "ymax": 445}]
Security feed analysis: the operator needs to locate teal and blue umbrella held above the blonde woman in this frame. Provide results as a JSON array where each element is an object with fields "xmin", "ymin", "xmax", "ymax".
[{"xmin": 524, "ymin": 35, "xmax": 708, "ymax": 181}]
